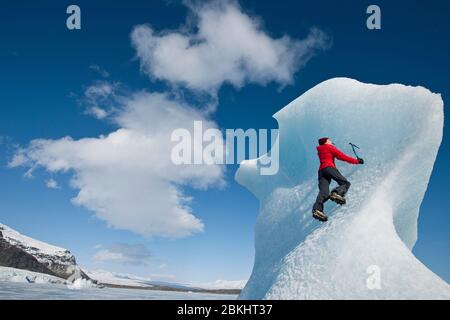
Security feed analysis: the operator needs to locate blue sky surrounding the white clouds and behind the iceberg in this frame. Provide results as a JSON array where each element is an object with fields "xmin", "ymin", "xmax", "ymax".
[{"xmin": 0, "ymin": 1, "xmax": 450, "ymax": 283}]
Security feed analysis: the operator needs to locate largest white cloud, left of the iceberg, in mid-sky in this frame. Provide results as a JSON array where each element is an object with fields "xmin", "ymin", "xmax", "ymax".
[{"xmin": 9, "ymin": 92, "xmax": 224, "ymax": 237}]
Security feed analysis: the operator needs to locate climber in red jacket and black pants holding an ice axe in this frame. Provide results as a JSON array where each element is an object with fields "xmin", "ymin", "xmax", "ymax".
[{"xmin": 312, "ymin": 137, "xmax": 364, "ymax": 221}]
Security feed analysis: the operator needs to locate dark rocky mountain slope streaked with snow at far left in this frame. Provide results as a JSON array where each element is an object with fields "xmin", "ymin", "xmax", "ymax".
[{"xmin": 0, "ymin": 224, "xmax": 89, "ymax": 280}]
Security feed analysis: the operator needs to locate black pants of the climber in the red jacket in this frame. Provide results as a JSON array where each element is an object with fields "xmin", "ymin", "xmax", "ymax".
[{"xmin": 313, "ymin": 167, "xmax": 350, "ymax": 212}]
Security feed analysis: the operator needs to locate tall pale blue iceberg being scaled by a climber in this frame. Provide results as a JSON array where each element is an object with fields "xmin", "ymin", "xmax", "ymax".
[{"xmin": 235, "ymin": 78, "xmax": 450, "ymax": 299}]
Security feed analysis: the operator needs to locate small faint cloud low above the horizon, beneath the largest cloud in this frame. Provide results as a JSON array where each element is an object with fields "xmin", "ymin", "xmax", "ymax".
[{"xmin": 94, "ymin": 243, "xmax": 151, "ymax": 265}]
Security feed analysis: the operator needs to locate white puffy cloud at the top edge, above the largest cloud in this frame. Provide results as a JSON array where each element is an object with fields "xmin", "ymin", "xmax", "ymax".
[{"xmin": 131, "ymin": 1, "xmax": 330, "ymax": 94}]
